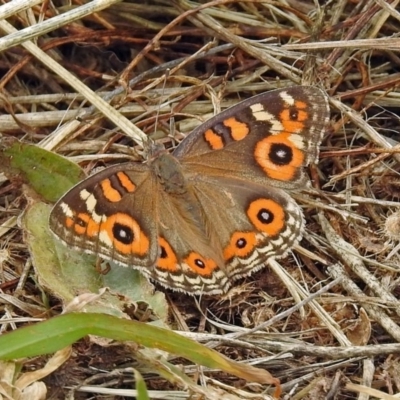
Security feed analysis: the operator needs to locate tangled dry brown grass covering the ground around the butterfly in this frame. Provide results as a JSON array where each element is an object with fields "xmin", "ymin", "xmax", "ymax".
[{"xmin": 0, "ymin": 0, "xmax": 400, "ymax": 399}]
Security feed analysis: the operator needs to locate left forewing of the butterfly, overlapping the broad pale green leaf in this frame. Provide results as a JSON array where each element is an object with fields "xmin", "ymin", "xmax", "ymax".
[{"xmin": 50, "ymin": 163, "xmax": 158, "ymax": 267}]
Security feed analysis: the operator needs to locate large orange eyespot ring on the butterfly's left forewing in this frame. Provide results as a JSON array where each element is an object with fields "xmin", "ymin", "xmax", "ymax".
[{"xmin": 100, "ymin": 213, "xmax": 150, "ymax": 256}]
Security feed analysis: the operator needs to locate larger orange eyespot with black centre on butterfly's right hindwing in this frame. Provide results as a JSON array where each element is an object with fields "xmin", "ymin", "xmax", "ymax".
[{"xmin": 247, "ymin": 199, "xmax": 285, "ymax": 236}]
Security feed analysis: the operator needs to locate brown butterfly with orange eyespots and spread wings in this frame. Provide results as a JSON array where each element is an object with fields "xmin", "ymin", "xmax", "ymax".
[{"xmin": 49, "ymin": 86, "xmax": 329, "ymax": 295}]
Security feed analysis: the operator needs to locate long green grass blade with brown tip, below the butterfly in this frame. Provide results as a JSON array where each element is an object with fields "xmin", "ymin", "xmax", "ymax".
[{"xmin": 0, "ymin": 313, "xmax": 279, "ymax": 384}]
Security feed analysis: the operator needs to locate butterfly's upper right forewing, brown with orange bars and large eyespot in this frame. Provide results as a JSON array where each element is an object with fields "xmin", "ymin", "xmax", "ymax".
[{"xmin": 174, "ymin": 87, "xmax": 329, "ymax": 188}]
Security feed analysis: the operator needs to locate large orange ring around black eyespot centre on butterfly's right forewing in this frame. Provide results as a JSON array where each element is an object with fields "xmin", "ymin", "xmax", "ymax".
[{"xmin": 254, "ymin": 132, "xmax": 305, "ymax": 181}]
